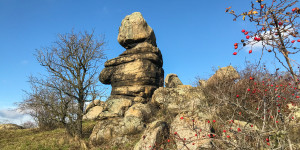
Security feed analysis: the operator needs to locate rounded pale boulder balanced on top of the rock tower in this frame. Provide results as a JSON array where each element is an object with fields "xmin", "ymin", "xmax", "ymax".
[{"xmin": 118, "ymin": 12, "xmax": 156, "ymax": 49}]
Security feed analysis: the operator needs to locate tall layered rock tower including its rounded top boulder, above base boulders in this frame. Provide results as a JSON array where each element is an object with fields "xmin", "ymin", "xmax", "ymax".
[{"xmin": 99, "ymin": 12, "xmax": 164, "ymax": 103}]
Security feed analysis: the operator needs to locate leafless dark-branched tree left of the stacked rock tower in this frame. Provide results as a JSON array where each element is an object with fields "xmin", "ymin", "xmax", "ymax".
[{"xmin": 18, "ymin": 31, "xmax": 105, "ymax": 138}]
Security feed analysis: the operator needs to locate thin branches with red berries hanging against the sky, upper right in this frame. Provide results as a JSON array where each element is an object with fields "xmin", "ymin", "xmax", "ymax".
[{"xmin": 225, "ymin": 0, "xmax": 300, "ymax": 89}]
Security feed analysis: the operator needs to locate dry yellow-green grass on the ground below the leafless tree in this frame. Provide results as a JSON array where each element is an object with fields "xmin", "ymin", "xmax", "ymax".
[{"xmin": 0, "ymin": 121, "xmax": 96, "ymax": 150}]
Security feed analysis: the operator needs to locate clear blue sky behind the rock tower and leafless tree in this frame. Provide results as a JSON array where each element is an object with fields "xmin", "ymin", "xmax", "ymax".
[{"xmin": 0, "ymin": 0, "xmax": 300, "ymax": 122}]
